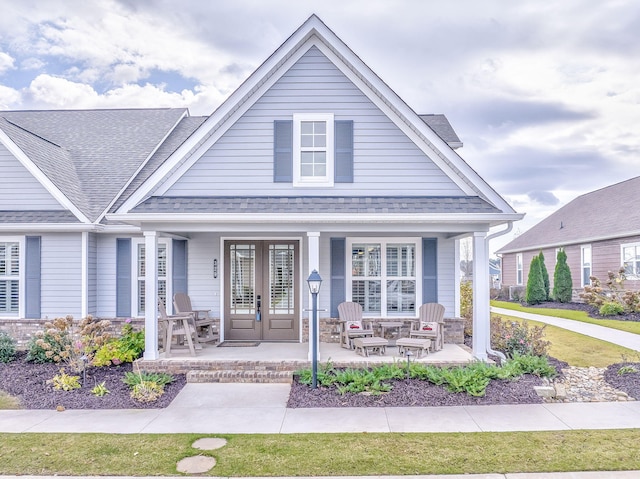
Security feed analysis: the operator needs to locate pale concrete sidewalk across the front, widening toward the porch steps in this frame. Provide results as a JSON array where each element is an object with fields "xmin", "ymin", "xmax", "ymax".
[{"xmin": 0, "ymin": 383, "xmax": 640, "ymax": 436}]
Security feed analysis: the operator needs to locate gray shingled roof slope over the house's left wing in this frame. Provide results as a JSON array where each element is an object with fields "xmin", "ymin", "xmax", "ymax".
[{"xmin": 0, "ymin": 108, "xmax": 188, "ymax": 221}]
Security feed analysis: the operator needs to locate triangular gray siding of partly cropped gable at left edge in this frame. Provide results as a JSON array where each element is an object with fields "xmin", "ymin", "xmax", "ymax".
[{"xmin": 0, "ymin": 145, "xmax": 64, "ymax": 210}]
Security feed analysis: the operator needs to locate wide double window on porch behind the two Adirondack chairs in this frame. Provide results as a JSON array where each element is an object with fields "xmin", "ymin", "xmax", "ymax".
[{"xmin": 347, "ymin": 238, "xmax": 421, "ymax": 317}]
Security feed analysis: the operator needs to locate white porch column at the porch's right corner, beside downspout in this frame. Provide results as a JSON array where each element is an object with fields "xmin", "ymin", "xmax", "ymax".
[{"xmin": 473, "ymin": 231, "xmax": 491, "ymax": 361}]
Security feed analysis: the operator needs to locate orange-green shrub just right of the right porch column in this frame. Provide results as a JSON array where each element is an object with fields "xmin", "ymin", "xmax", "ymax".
[{"xmin": 491, "ymin": 316, "xmax": 551, "ymax": 358}]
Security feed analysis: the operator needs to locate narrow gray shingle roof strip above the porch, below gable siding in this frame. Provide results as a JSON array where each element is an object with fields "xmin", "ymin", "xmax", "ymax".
[{"xmin": 132, "ymin": 196, "xmax": 500, "ymax": 214}]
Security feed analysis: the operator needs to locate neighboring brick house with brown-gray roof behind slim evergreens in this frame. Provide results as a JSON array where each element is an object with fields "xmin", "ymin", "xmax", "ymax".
[{"xmin": 497, "ymin": 177, "xmax": 640, "ymax": 298}]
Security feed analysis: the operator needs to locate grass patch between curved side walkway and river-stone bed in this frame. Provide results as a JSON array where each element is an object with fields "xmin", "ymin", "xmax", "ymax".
[{"xmin": 492, "ymin": 313, "xmax": 640, "ymax": 368}]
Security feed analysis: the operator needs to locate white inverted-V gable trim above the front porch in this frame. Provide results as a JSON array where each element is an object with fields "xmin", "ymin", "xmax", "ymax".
[{"xmin": 117, "ymin": 15, "xmax": 522, "ymax": 218}]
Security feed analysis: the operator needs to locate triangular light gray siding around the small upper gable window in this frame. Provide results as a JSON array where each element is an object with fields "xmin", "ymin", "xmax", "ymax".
[{"xmin": 167, "ymin": 48, "xmax": 463, "ymax": 196}]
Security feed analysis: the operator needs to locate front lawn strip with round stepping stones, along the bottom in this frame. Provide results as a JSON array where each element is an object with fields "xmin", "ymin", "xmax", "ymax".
[{"xmin": 0, "ymin": 429, "xmax": 640, "ymax": 477}]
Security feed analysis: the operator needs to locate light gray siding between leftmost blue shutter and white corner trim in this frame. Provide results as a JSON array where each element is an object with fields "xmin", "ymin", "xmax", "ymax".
[{"xmin": 42, "ymin": 233, "xmax": 82, "ymax": 319}]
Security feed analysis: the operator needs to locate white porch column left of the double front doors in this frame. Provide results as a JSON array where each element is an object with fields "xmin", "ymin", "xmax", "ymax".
[{"xmin": 144, "ymin": 231, "xmax": 158, "ymax": 360}]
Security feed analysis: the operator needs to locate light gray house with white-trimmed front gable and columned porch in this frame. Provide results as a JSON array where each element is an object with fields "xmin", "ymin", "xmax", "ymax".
[{"xmin": 0, "ymin": 16, "xmax": 522, "ymax": 360}]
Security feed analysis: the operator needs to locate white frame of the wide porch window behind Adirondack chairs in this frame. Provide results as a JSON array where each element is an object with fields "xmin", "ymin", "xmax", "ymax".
[{"xmin": 346, "ymin": 237, "xmax": 422, "ymax": 318}]
